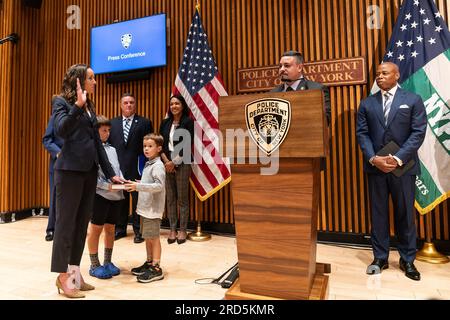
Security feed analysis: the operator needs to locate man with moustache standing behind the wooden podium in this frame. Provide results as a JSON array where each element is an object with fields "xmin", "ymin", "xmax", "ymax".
[{"xmin": 271, "ymin": 51, "xmax": 331, "ymax": 125}]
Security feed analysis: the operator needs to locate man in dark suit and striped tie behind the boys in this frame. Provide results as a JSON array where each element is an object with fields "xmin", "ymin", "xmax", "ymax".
[{"xmin": 109, "ymin": 93, "xmax": 153, "ymax": 243}]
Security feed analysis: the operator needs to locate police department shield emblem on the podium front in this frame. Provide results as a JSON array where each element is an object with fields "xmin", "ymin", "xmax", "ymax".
[{"xmin": 245, "ymin": 98, "xmax": 291, "ymax": 156}]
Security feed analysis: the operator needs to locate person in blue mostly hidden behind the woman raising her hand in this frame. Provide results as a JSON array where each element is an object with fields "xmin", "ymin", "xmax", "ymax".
[{"xmin": 42, "ymin": 116, "xmax": 64, "ymax": 241}]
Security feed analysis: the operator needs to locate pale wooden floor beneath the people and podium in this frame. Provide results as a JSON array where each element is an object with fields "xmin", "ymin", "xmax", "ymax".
[{"xmin": 0, "ymin": 217, "xmax": 450, "ymax": 300}]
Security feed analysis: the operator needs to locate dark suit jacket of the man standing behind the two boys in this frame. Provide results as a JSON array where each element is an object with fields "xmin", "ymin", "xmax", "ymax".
[{"xmin": 109, "ymin": 114, "xmax": 153, "ymax": 180}]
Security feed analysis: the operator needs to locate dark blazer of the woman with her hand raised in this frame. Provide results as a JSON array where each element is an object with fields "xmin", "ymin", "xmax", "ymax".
[{"xmin": 52, "ymin": 97, "xmax": 115, "ymax": 178}]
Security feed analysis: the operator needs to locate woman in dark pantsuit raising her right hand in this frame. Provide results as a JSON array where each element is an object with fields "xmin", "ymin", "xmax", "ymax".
[{"xmin": 51, "ymin": 64, "xmax": 122, "ymax": 298}]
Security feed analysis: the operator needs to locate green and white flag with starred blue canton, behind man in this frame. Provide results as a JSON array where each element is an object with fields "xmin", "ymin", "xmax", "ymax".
[{"xmin": 372, "ymin": 0, "xmax": 450, "ymax": 214}]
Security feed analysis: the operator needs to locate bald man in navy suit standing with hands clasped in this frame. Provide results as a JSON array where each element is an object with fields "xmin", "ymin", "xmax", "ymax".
[{"xmin": 356, "ymin": 62, "xmax": 427, "ymax": 280}]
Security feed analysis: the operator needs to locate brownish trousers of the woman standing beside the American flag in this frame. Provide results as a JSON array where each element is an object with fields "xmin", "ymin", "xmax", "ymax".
[{"xmin": 166, "ymin": 164, "xmax": 191, "ymax": 231}]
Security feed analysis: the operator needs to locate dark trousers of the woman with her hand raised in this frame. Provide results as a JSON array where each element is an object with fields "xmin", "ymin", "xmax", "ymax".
[{"xmin": 51, "ymin": 166, "xmax": 97, "ymax": 273}]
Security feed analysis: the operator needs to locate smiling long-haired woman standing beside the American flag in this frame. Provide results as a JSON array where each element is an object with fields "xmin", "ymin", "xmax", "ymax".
[{"xmin": 159, "ymin": 94, "xmax": 194, "ymax": 244}]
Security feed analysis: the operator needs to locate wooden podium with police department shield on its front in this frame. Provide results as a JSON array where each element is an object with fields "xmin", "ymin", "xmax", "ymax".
[{"xmin": 219, "ymin": 90, "xmax": 330, "ymax": 300}]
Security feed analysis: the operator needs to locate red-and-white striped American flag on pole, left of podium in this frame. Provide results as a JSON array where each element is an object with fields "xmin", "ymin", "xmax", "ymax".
[{"xmin": 172, "ymin": 8, "xmax": 231, "ymax": 201}]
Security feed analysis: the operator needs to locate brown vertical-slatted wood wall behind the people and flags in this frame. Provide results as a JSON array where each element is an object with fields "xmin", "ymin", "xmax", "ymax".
[{"xmin": 0, "ymin": 0, "xmax": 450, "ymax": 240}]
